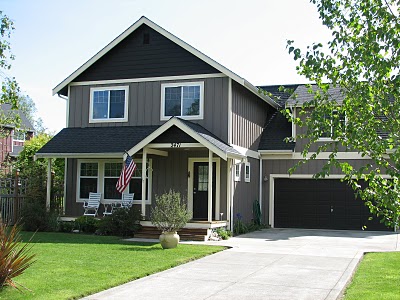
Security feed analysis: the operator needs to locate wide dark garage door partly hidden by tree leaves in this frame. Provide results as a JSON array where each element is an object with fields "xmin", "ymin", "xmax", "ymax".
[{"xmin": 274, "ymin": 178, "xmax": 389, "ymax": 230}]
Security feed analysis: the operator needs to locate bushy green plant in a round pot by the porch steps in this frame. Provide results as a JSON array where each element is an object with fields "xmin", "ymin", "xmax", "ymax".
[{"xmin": 150, "ymin": 190, "xmax": 192, "ymax": 249}]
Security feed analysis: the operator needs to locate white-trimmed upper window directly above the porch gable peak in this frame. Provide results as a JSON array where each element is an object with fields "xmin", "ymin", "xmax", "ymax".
[{"xmin": 161, "ymin": 82, "xmax": 204, "ymax": 120}]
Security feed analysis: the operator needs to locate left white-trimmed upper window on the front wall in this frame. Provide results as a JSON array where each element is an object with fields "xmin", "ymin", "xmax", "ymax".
[{"xmin": 89, "ymin": 86, "xmax": 129, "ymax": 123}]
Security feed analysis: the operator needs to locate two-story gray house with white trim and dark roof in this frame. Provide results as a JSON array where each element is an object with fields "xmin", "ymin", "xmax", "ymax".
[{"xmin": 36, "ymin": 17, "xmax": 388, "ymax": 233}]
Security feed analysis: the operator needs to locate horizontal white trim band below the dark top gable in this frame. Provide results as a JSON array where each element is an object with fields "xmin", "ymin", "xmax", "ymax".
[{"xmin": 69, "ymin": 73, "xmax": 226, "ymax": 86}]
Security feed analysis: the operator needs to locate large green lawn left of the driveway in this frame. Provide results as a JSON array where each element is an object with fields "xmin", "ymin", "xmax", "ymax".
[{"xmin": 0, "ymin": 232, "xmax": 224, "ymax": 300}]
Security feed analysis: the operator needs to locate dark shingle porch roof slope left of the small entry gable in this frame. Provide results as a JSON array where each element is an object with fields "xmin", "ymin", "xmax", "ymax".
[{"xmin": 37, "ymin": 126, "xmax": 159, "ymax": 154}]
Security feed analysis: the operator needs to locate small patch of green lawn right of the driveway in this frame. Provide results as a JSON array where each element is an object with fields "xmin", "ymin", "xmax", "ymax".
[{"xmin": 344, "ymin": 252, "xmax": 400, "ymax": 300}]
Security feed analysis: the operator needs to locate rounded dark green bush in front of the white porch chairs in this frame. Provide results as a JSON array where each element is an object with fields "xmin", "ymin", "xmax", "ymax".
[{"xmin": 97, "ymin": 206, "xmax": 141, "ymax": 236}]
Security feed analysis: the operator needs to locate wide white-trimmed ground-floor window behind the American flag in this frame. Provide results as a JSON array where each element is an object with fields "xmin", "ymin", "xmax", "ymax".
[{"xmin": 77, "ymin": 159, "xmax": 152, "ymax": 204}]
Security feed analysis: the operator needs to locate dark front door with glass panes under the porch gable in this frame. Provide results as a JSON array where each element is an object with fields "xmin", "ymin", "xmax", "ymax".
[{"xmin": 193, "ymin": 162, "xmax": 216, "ymax": 220}]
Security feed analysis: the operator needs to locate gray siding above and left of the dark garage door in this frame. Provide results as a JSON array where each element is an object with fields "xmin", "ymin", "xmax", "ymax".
[{"xmin": 262, "ymin": 159, "xmax": 371, "ymax": 224}]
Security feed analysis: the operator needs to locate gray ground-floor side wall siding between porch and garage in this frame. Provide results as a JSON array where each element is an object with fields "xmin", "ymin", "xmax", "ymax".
[{"xmin": 233, "ymin": 158, "xmax": 260, "ymax": 223}]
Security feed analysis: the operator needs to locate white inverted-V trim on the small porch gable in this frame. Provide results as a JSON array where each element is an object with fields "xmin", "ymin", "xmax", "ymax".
[{"xmin": 128, "ymin": 117, "xmax": 228, "ymax": 160}]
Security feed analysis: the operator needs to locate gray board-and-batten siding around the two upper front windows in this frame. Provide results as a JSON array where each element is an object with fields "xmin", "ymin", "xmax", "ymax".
[{"xmin": 68, "ymin": 77, "xmax": 228, "ymax": 142}]
